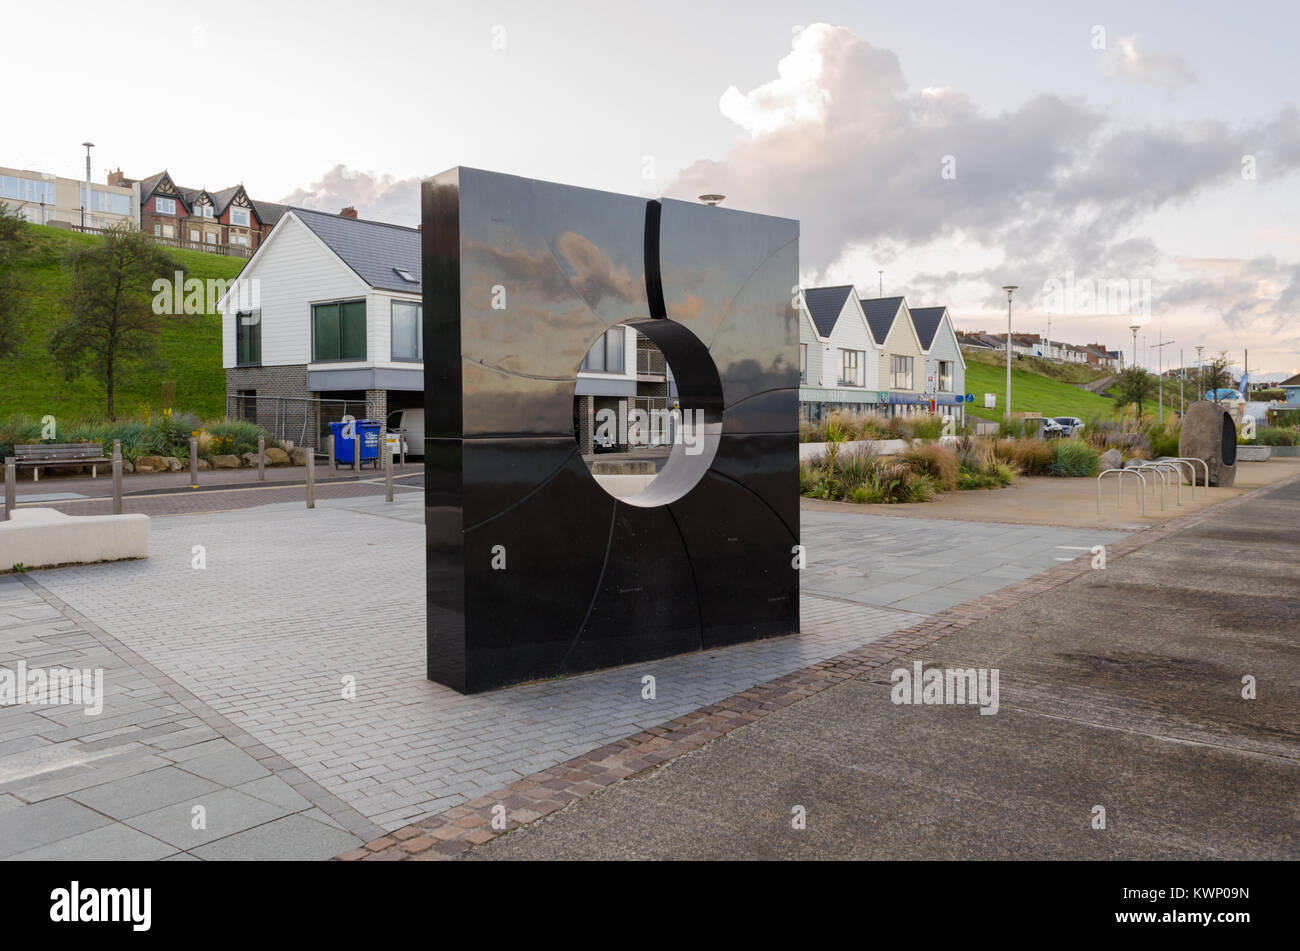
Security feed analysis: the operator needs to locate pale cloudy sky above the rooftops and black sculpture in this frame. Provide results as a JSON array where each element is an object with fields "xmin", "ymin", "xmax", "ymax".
[{"xmin": 10, "ymin": 0, "xmax": 1300, "ymax": 375}]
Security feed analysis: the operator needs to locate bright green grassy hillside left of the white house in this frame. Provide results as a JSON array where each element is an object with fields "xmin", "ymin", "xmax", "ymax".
[{"xmin": 0, "ymin": 225, "xmax": 244, "ymax": 420}]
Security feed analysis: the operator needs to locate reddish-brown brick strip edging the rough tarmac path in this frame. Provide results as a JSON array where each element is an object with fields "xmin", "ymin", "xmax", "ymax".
[{"xmin": 337, "ymin": 467, "xmax": 1300, "ymax": 861}]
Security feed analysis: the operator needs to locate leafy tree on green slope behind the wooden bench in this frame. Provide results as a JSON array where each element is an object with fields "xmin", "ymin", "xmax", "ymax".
[{"xmin": 49, "ymin": 227, "xmax": 174, "ymax": 420}]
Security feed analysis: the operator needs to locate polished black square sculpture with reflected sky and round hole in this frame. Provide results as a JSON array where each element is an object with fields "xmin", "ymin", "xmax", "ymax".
[{"xmin": 421, "ymin": 168, "xmax": 800, "ymax": 692}]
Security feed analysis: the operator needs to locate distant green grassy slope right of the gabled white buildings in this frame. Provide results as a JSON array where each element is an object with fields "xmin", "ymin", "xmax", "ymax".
[{"xmin": 965, "ymin": 353, "xmax": 1115, "ymax": 421}]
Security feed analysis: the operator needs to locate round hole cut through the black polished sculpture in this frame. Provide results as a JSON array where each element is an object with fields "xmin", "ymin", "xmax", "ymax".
[{"xmin": 573, "ymin": 318, "xmax": 723, "ymax": 508}]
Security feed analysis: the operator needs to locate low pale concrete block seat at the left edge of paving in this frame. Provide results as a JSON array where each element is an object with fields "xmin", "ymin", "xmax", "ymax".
[{"xmin": 0, "ymin": 508, "xmax": 150, "ymax": 568}]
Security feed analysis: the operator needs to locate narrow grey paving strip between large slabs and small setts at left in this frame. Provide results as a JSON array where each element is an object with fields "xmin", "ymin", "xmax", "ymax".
[{"xmin": 14, "ymin": 574, "xmax": 384, "ymax": 838}]
